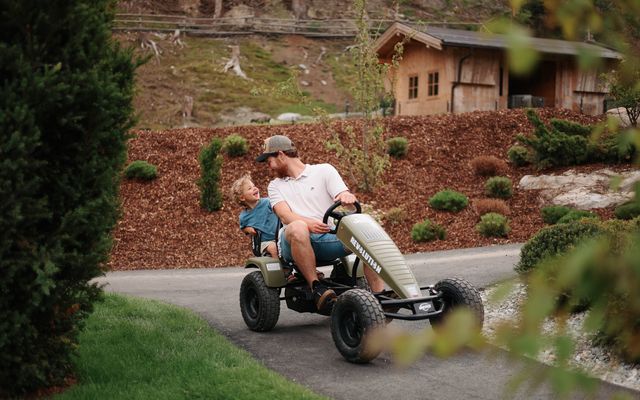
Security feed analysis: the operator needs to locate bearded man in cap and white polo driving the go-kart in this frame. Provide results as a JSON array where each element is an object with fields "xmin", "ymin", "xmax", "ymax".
[{"xmin": 256, "ymin": 135, "xmax": 384, "ymax": 310}]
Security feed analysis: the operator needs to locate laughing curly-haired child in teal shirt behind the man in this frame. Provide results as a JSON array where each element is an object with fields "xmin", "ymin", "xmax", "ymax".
[{"xmin": 231, "ymin": 174, "xmax": 278, "ymax": 258}]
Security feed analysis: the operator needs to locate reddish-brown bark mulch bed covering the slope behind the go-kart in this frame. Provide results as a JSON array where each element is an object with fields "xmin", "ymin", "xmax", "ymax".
[{"xmin": 109, "ymin": 109, "xmax": 612, "ymax": 270}]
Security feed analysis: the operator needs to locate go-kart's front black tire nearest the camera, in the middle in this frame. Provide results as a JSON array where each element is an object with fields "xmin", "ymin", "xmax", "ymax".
[{"xmin": 331, "ymin": 289, "xmax": 385, "ymax": 363}]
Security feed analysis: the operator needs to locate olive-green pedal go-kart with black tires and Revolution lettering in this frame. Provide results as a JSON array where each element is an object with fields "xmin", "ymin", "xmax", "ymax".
[{"xmin": 240, "ymin": 201, "xmax": 484, "ymax": 363}]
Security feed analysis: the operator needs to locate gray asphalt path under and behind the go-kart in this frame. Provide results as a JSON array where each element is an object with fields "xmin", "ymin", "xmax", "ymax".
[{"xmin": 100, "ymin": 245, "xmax": 639, "ymax": 400}]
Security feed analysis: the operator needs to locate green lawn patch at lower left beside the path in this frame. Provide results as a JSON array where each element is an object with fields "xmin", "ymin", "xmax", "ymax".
[{"xmin": 54, "ymin": 294, "xmax": 323, "ymax": 400}]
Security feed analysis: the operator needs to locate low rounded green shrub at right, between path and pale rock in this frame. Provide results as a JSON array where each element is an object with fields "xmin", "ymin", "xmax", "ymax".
[{"xmin": 514, "ymin": 220, "xmax": 604, "ymax": 274}]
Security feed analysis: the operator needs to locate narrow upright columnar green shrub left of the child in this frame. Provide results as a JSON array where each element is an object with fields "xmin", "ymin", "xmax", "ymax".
[{"xmin": 198, "ymin": 138, "xmax": 223, "ymax": 211}]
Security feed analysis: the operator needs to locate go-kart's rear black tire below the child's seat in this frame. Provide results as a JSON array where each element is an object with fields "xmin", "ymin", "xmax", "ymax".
[{"xmin": 240, "ymin": 271, "xmax": 280, "ymax": 332}]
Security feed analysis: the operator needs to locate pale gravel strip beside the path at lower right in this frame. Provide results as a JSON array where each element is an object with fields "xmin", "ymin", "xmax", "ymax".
[{"xmin": 481, "ymin": 283, "xmax": 640, "ymax": 390}]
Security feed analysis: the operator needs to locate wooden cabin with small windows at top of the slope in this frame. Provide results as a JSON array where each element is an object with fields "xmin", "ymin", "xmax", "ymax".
[{"xmin": 375, "ymin": 22, "xmax": 620, "ymax": 115}]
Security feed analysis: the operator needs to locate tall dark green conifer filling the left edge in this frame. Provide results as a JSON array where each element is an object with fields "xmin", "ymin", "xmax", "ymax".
[{"xmin": 0, "ymin": 0, "xmax": 136, "ymax": 398}]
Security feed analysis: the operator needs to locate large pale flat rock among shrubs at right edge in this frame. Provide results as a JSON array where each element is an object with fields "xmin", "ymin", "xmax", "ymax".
[{"xmin": 518, "ymin": 169, "xmax": 640, "ymax": 210}]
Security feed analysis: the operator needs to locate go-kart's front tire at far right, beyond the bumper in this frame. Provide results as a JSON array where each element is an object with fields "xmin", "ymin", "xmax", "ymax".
[{"xmin": 430, "ymin": 278, "xmax": 484, "ymax": 330}]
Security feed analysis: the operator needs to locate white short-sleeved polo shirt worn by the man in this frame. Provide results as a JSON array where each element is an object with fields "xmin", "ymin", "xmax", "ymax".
[{"xmin": 268, "ymin": 164, "xmax": 349, "ymax": 220}]
